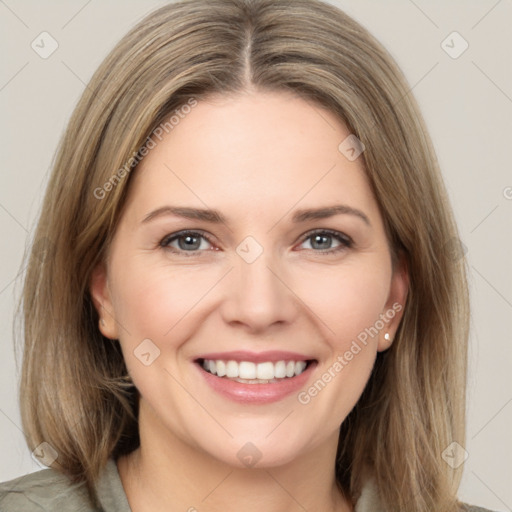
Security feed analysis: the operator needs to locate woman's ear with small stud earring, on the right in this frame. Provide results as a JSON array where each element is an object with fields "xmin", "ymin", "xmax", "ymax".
[{"xmin": 377, "ymin": 253, "xmax": 409, "ymax": 352}]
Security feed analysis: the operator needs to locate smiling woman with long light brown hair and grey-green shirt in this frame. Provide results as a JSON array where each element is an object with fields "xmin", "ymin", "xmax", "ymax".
[{"xmin": 0, "ymin": 0, "xmax": 496, "ymax": 512}]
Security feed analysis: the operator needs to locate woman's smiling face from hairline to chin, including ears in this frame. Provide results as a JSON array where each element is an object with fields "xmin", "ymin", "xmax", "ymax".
[{"xmin": 91, "ymin": 92, "xmax": 407, "ymax": 467}]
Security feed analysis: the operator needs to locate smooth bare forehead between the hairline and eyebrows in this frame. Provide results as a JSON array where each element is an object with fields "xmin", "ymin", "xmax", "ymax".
[{"xmin": 124, "ymin": 92, "xmax": 376, "ymax": 226}]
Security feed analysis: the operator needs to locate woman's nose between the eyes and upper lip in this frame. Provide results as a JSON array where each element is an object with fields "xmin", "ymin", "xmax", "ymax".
[{"xmin": 221, "ymin": 251, "xmax": 300, "ymax": 333}]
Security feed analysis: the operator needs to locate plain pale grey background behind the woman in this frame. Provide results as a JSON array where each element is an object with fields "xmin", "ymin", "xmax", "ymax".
[{"xmin": 0, "ymin": 0, "xmax": 512, "ymax": 511}]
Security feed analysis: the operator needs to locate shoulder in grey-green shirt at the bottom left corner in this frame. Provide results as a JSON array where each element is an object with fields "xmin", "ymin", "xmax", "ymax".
[{"xmin": 0, "ymin": 469, "xmax": 95, "ymax": 512}]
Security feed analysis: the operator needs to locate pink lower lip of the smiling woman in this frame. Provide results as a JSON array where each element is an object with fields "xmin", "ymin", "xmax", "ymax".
[{"xmin": 194, "ymin": 361, "xmax": 317, "ymax": 404}]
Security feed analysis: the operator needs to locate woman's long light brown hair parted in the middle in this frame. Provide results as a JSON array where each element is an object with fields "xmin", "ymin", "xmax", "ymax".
[{"xmin": 20, "ymin": 0, "xmax": 469, "ymax": 512}]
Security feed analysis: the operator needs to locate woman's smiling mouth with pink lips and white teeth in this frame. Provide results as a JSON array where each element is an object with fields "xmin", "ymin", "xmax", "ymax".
[{"xmin": 194, "ymin": 352, "xmax": 318, "ymax": 403}]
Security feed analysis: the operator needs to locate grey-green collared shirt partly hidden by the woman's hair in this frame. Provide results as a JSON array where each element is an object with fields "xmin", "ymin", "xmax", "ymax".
[{"xmin": 0, "ymin": 459, "xmax": 498, "ymax": 512}]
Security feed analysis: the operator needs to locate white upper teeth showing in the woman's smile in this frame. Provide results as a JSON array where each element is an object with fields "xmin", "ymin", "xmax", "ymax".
[{"xmin": 199, "ymin": 359, "xmax": 307, "ymax": 384}]
